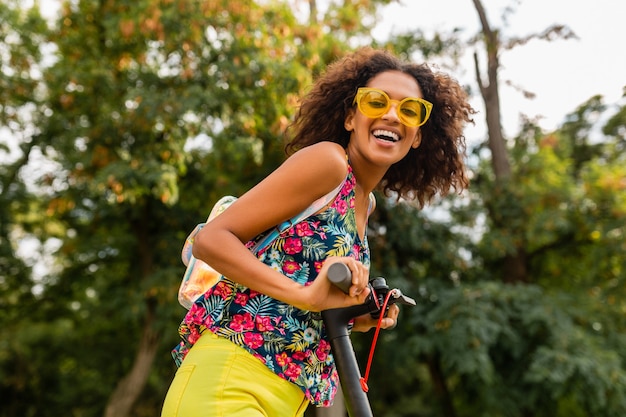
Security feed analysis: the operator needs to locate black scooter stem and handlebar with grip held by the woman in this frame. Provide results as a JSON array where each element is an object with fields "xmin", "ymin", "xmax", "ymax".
[{"xmin": 322, "ymin": 263, "xmax": 415, "ymax": 417}]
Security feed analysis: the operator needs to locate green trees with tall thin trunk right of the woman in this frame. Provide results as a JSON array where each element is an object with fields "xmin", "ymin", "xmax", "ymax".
[{"xmin": 352, "ymin": 2, "xmax": 626, "ymax": 416}]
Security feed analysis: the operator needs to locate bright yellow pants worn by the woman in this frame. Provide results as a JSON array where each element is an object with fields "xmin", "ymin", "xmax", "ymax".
[{"xmin": 161, "ymin": 331, "xmax": 309, "ymax": 417}]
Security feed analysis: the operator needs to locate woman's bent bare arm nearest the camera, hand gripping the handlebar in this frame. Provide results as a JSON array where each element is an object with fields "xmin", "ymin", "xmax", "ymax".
[{"xmin": 193, "ymin": 142, "xmax": 369, "ymax": 311}]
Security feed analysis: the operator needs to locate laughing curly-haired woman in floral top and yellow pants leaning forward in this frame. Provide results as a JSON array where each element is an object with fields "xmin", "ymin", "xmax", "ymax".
[{"xmin": 162, "ymin": 48, "xmax": 474, "ymax": 417}]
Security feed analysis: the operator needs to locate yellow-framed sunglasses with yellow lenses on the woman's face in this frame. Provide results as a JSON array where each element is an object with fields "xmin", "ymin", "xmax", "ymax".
[{"xmin": 352, "ymin": 87, "xmax": 433, "ymax": 127}]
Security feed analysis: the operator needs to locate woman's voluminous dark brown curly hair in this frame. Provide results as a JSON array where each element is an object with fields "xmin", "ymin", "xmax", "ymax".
[{"xmin": 285, "ymin": 47, "xmax": 475, "ymax": 207}]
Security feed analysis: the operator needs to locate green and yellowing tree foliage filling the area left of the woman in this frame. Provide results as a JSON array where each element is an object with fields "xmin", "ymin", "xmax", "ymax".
[{"xmin": 0, "ymin": 0, "xmax": 394, "ymax": 417}]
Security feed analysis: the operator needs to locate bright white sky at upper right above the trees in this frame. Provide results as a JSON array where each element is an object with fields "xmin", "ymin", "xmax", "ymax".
[{"xmin": 375, "ymin": 0, "xmax": 626, "ymax": 139}]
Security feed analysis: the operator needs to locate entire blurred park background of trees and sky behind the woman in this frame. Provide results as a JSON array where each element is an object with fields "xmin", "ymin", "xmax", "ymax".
[{"xmin": 0, "ymin": 0, "xmax": 626, "ymax": 417}]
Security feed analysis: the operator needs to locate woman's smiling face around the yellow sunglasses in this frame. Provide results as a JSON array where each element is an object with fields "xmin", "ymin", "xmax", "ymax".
[{"xmin": 344, "ymin": 71, "xmax": 422, "ymax": 168}]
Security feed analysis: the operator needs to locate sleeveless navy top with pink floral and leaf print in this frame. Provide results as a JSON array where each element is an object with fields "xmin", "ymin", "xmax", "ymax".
[{"xmin": 172, "ymin": 161, "xmax": 369, "ymax": 406}]
